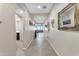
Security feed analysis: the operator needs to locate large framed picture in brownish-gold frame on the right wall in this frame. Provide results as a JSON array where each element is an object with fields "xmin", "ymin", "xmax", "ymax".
[{"xmin": 58, "ymin": 3, "xmax": 79, "ymax": 31}]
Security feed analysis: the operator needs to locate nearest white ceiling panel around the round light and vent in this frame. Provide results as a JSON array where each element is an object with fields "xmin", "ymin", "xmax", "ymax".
[{"xmin": 25, "ymin": 3, "xmax": 53, "ymax": 14}]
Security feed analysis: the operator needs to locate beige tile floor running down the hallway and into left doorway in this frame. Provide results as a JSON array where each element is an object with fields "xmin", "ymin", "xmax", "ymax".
[{"xmin": 16, "ymin": 33, "xmax": 57, "ymax": 56}]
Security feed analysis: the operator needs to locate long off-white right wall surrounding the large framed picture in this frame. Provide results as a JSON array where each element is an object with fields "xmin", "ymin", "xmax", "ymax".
[{"xmin": 48, "ymin": 3, "xmax": 79, "ymax": 56}]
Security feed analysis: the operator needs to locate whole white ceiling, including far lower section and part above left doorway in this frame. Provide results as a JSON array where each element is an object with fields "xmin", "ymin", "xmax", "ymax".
[{"xmin": 16, "ymin": 3, "xmax": 54, "ymax": 23}]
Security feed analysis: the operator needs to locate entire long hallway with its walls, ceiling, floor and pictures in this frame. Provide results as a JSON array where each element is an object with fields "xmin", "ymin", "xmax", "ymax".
[{"xmin": 0, "ymin": 3, "xmax": 79, "ymax": 56}]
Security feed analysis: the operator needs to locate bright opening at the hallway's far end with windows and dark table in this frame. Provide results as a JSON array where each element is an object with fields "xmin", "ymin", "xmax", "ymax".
[{"xmin": 35, "ymin": 23, "xmax": 48, "ymax": 39}]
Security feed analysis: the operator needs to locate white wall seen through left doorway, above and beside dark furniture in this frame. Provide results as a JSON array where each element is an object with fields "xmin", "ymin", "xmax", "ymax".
[{"xmin": 15, "ymin": 14, "xmax": 23, "ymax": 40}]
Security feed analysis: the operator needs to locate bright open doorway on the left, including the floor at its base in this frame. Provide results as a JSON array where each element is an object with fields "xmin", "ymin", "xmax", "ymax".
[{"xmin": 15, "ymin": 7, "xmax": 24, "ymax": 55}]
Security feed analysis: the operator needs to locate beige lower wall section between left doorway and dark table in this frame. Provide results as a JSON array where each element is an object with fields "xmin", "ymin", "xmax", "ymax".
[{"xmin": 23, "ymin": 31, "xmax": 34, "ymax": 48}]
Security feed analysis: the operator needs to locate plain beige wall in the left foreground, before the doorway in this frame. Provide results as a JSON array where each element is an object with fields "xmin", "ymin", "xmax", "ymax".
[{"xmin": 0, "ymin": 3, "xmax": 16, "ymax": 55}]
